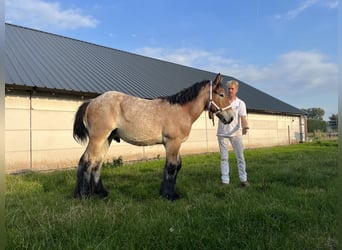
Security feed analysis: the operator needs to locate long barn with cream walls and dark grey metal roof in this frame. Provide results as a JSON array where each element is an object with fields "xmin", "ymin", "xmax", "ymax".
[{"xmin": 5, "ymin": 24, "xmax": 306, "ymax": 173}]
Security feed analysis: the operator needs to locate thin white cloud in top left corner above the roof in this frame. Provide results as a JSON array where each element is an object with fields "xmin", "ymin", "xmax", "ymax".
[{"xmin": 5, "ymin": 0, "xmax": 98, "ymax": 30}]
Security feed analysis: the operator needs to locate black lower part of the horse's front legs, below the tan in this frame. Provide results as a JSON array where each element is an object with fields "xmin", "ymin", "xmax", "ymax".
[{"xmin": 160, "ymin": 160, "xmax": 182, "ymax": 200}]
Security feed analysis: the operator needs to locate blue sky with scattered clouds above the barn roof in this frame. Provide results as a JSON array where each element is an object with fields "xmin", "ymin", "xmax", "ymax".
[{"xmin": 5, "ymin": 0, "xmax": 342, "ymax": 120}]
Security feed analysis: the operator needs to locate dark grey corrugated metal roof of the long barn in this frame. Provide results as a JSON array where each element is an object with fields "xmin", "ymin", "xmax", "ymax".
[{"xmin": 5, "ymin": 24, "xmax": 304, "ymax": 114}]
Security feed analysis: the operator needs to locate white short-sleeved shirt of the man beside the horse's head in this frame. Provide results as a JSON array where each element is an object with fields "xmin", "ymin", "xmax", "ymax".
[{"xmin": 217, "ymin": 97, "xmax": 247, "ymax": 137}]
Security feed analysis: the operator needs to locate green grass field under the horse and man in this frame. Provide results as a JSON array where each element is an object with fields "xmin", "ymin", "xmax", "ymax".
[{"xmin": 5, "ymin": 141, "xmax": 337, "ymax": 250}]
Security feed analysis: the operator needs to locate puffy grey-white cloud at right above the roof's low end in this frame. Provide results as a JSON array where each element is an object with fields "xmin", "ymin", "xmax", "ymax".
[{"xmin": 232, "ymin": 51, "xmax": 338, "ymax": 95}]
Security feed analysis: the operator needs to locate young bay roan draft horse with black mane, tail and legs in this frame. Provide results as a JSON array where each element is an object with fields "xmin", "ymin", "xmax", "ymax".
[{"xmin": 73, "ymin": 74, "xmax": 234, "ymax": 200}]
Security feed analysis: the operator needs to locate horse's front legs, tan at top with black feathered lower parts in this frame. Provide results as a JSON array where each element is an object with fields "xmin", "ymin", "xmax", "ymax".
[{"xmin": 160, "ymin": 143, "xmax": 182, "ymax": 200}]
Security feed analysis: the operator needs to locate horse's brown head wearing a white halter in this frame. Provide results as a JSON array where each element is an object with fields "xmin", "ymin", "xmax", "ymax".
[{"xmin": 208, "ymin": 74, "xmax": 234, "ymax": 124}]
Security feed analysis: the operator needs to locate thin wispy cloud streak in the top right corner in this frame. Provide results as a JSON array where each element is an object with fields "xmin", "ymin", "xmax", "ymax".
[{"xmin": 274, "ymin": 0, "xmax": 338, "ymax": 20}]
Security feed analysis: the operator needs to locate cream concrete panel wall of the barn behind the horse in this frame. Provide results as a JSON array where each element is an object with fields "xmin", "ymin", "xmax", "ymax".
[{"xmin": 5, "ymin": 91, "xmax": 300, "ymax": 173}]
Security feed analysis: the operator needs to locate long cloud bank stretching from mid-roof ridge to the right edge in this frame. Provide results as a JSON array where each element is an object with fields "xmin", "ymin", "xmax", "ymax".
[{"xmin": 136, "ymin": 47, "xmax": 338, "ymax": 96}]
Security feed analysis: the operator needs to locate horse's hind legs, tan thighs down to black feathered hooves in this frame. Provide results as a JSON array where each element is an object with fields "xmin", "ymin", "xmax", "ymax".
[{"xmin": 74, "ymin": 139, "xmax": 110, "ymax": 198}]
